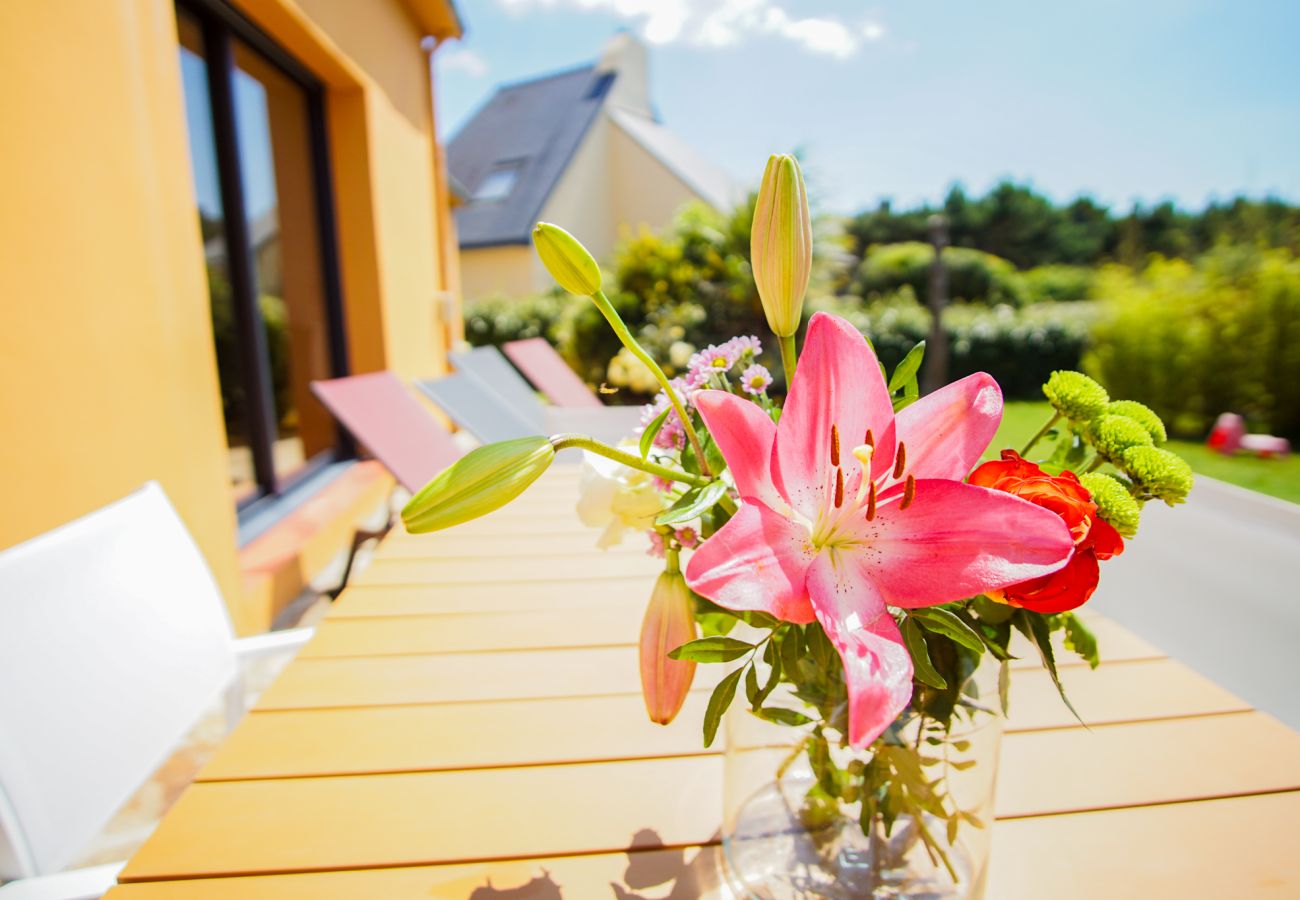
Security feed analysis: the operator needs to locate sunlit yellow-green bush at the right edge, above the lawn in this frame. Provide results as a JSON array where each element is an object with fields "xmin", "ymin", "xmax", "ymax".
[{"xmin": 1086, "ymin": 247, "xmax": 1300, "ymax": 437}]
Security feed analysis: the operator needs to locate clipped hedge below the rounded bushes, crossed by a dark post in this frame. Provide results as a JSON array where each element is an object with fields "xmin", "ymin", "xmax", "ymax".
[{"xmin": 819, "ymin": 289, "xmax": 1099, "ymax": 399}]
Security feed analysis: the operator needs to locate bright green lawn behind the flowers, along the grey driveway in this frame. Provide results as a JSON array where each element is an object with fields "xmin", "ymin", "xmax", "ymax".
[{"xmin": 987, "ymin": 401, "xmax": 1300, "ymax": 503}]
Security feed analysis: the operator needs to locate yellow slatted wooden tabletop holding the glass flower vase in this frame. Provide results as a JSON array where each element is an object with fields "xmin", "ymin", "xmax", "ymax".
[{"xmin": 108, "ymin": 467, "xmax": 1300, "ymax": 900}]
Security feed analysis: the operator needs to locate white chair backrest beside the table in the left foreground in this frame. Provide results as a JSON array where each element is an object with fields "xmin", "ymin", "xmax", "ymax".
[{"xmin": 0, "ymin": 483, "xmax": 237, "ymax": 879}]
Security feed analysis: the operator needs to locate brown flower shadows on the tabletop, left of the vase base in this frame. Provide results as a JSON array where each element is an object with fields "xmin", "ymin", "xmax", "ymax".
[{"xmin": 469, "ymin": 828, "xmax": 719, "ymax": 900}]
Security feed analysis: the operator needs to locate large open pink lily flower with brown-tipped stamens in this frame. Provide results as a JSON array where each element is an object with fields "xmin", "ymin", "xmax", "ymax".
[{"xmin": 686, "ymin": 312, "xmax": 1074, "ymax": 748}]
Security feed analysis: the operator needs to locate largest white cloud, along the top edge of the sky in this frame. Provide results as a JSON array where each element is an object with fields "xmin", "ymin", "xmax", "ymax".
[{"xmin": 498, "ymin": 0, "xmax": 885, "ymax": 60}]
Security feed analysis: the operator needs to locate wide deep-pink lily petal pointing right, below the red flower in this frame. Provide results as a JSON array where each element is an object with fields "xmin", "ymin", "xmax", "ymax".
[{"xmin": 859, "ymin": 479, "xmax": 1074, "ymax": 609}]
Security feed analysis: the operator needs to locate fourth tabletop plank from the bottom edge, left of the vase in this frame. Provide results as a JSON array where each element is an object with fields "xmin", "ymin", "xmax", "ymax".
[{"xmin": 257, "ymin": 646, "xmax": 723, "ymax": 712}]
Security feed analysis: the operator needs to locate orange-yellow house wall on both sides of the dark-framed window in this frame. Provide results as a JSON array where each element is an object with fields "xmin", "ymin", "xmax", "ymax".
[{"xmin": 0, "ymin": 0, "xmax": 456, "ymax": 632}]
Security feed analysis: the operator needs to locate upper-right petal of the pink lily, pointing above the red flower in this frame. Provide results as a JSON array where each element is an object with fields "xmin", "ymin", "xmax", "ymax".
[{"xmin": 897, "ymin": 372, "xmax": 1002, "ymax": 481}]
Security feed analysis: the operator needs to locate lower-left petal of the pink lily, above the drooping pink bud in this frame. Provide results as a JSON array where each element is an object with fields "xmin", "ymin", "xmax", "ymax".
[{"xmin": 686, "ymin": 502, "xmax": 814, "ymax": 624}]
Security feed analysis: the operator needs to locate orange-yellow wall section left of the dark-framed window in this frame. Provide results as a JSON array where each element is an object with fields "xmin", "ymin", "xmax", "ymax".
[{"xmin": 0, "ymin": 0, "xmax": 239, "ymax": 618}]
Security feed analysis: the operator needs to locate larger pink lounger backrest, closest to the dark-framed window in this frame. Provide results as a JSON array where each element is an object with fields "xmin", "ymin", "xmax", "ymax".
[{"xmin": 312, "ymin": 372, "xmax": 460, "ymax": 493}]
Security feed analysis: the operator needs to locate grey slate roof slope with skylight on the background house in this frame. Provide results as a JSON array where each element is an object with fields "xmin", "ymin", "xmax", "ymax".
[{"xmin": 447, "ymin": 65, "xmax": 615, "ymax": 248}]
